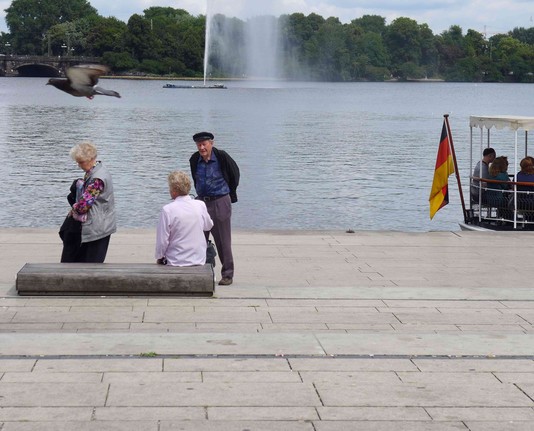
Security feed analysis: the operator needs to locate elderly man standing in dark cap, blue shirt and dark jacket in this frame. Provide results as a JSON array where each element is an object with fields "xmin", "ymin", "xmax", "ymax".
[{"xmin": 189, "ymin": 132, "xmax": 239, "ymax": 286}]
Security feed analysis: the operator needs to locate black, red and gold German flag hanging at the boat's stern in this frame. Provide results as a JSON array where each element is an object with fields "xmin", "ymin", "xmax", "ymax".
[{"xmin": 428, "ymin": 121, "xmax": 454, "ymax": 219}]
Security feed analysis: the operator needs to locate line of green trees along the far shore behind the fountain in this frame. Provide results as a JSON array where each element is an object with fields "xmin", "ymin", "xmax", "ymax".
[{"xmin": 0, "ymin": 0, "xmax": 534, "ymax": 82}]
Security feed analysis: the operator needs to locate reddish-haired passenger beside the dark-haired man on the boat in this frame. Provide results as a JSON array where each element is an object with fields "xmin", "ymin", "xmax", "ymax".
[{"xmin": 485, "ymin": 156, "xmax": 512, "ymax": 220}]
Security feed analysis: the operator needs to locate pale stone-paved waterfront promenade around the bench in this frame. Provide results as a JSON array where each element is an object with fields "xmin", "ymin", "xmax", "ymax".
[{"xmin": 0, "ymin": 229, "xmax": 534, "ymax": 431}]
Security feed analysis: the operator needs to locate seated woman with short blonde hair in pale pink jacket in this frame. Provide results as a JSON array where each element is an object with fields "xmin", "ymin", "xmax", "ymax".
[{"xmin": 156, "ymin": 171, "xmax": 213, "ymax": 266}]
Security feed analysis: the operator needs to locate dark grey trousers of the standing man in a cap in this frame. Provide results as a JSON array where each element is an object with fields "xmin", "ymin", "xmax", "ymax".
[{"xmin": 206, "ymin": 195, "xmax": 234, "ymax": 278}]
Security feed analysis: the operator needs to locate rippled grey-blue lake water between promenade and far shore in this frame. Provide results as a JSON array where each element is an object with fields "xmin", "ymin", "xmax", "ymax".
[{"xmin": 0, "ymin": 78, "xmax": 534, "ymax": 231}]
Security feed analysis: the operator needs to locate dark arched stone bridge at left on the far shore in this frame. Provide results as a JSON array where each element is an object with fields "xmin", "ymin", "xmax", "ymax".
[{"xmin": 0, "ymin": 55, "xmax": 100, "ymax": 77}]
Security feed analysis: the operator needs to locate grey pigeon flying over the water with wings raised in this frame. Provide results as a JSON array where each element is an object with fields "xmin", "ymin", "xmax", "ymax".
[{"xmin": 46, "ymin": 64, "xmax": 121, "ymax": 99}]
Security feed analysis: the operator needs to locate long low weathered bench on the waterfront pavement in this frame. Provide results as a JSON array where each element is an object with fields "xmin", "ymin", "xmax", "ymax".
[{"xmin": 16, "ymin": 263, "xmax": 215, "ymax": 296}]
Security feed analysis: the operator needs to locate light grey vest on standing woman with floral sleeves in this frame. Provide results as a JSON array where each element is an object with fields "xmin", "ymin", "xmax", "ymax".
[{"xmin": 82, "ymin": 162, "xmax": 117, "ymax": 243}]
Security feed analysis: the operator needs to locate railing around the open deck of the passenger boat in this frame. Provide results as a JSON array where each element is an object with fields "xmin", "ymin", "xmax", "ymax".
[{"xmin": 469, "ymin": 177, "xmax": 534, "ymax": 228}]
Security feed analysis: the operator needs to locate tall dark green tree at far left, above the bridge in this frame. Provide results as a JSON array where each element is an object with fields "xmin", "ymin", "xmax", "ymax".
[{"xmin": 6, "ymin": 0, "xmax": 97, "ymax": 54}]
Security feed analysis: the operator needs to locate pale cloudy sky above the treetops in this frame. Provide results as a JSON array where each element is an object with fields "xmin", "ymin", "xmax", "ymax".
[{"xmin": 0, "ymin": 0, "xmax": 534, "ymax": 37}]
